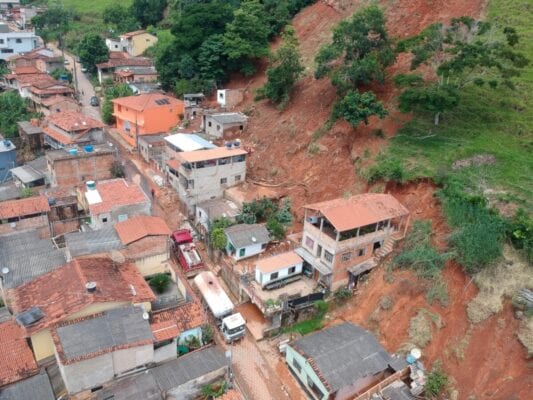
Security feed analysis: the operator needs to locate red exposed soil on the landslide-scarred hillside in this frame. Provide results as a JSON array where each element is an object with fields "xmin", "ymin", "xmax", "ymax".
[{"xmin": 220, "ymin": 0, "xmax": 533, "ymax": 399}]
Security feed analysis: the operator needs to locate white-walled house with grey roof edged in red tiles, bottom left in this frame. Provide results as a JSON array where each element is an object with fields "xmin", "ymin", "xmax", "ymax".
[{"xmin": 52, "ymin": 305, "xmax": 154, "ymax": 394}]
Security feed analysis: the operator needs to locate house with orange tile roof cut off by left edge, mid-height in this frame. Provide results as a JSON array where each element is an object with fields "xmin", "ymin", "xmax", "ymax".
[{"xmin": 0, "ymin": 196, "xmax": 50, "ymax": 238}]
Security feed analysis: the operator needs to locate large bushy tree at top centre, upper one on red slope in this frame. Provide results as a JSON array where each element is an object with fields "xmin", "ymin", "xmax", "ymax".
[{"xmin": 315, "ymin": 6, "xmax": 396, "ymax": 96}]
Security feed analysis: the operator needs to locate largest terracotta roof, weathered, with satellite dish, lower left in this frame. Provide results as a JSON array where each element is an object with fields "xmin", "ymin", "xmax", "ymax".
[{"xmin": 7, "ymin": 257, "xmax": 155, "ymax": 334}]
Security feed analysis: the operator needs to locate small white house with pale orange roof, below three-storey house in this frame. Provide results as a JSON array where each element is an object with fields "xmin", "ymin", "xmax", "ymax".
[{"xmin": 255, "ymin": 251, "xmax": 303, "ymax": 288}]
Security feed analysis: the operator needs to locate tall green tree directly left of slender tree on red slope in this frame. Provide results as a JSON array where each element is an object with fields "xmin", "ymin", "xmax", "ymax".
[{"xmin": 224, "ymin": 0, "xmax": 270, "ymax": 75}]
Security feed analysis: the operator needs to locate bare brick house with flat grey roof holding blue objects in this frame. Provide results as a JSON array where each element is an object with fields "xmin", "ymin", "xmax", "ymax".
[{"xmin": 46, "ymin": 144, "xmax": 117, "ymax": 187}]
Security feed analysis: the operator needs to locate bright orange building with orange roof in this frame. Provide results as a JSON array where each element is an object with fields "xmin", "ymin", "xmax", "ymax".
[{"xmin": 113, "ymin": 93, "xmax": 184, "ymax": 147}]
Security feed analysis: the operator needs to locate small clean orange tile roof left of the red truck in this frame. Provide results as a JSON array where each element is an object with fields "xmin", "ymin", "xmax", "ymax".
[{"xmin": 115, "ymin": 215, "xmax": 172, "ymax": 244}]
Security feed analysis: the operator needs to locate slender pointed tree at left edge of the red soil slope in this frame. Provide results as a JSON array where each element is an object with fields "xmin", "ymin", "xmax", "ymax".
[{"xmin": 258, "ymin": 26, "xmax": 304, "ymax": 107}]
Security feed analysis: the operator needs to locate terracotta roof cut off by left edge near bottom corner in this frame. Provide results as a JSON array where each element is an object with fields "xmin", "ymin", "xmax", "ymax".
[{"xmin": 0, "ymin": 320, "xmax": 39, "ymax": 391}]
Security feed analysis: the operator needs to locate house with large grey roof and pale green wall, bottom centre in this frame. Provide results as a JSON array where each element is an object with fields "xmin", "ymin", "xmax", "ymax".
[{"xmin": 285, "ymin": 322, "xmax": 409, "ymax": 400}]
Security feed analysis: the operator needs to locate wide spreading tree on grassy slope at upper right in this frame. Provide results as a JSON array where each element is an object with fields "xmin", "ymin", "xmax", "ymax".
[{"xmin": 396, "ymin": 17, "xmax": 528, "ymax": 125}]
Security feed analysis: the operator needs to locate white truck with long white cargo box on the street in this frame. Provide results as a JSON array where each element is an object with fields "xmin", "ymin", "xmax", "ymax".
[{"xmin": 194, "ymin": 271, "xmax": 246, "ymax": 343}]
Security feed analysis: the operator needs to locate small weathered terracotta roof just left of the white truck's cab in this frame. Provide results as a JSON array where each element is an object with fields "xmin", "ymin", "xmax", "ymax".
[{"xmin": 150, "ymin": 299, "xmax": 207, "ymax": 342}]
